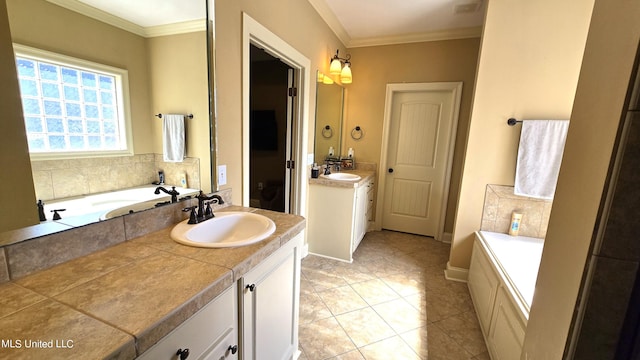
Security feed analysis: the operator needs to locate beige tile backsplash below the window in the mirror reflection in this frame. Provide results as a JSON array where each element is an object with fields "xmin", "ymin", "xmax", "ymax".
[{"xmin": 31, "ymin": 154, "xmax": 200, "ymax": 200}]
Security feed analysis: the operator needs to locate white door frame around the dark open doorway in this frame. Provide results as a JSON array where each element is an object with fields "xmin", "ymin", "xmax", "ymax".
[{"xmin": 242, "ymin": 13, "xmax": 311, "ymax": 216}]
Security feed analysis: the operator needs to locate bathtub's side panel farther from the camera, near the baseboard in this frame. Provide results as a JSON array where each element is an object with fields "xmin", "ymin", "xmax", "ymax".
[{"xmin": 467, "ymin": 240, "xmax": 500, "ymax": 336}]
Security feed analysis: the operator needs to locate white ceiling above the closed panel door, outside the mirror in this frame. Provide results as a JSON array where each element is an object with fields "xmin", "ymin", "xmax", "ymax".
[{"xmin": 309, "ymin": 0, "xmax": 484, "ymax": 47}]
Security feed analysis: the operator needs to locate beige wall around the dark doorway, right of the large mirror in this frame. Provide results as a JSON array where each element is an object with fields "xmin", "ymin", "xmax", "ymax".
[{"xmin": 215, "ymin": 0, "xmax": 344, "ymax": 204}]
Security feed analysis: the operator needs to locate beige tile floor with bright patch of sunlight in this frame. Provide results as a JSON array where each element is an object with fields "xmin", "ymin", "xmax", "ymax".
[{"xmin": 299, "ymin": 231, "xmax": 489, "ymax": 360}]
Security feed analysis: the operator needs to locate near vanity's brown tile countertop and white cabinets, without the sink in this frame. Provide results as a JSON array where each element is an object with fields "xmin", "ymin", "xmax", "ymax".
[{"xmin": 0, "ymin": 206, "xmax": 305, "ymax": 360}]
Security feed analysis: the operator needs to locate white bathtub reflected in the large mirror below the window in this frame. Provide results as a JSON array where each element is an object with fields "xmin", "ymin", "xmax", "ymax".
[{"xmin": 44, "ymin": 185, "xmax": 200, "ymax": 226}]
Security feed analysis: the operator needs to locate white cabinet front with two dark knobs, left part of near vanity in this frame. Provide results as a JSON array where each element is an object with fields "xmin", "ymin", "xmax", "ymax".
[{"xmin": 138, "ymin": 284, "xmax": 239, "ymax": 360}]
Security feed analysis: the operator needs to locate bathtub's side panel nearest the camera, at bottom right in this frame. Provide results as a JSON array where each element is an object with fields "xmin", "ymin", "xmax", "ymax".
[{"xmin": 487, "ymin": 287, "xmax": 525, "ymax": 360}]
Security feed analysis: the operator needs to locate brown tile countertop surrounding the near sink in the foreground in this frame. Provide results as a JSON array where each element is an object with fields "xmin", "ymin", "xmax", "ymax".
[{"xmin": 0, "ymin": 206, "xmax": 305, "ymax": 359}]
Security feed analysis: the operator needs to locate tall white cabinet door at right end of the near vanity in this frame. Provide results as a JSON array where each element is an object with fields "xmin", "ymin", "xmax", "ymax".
[{"xmin": 238, "ymin": 232, "xmax": 304, "ymax": 360}]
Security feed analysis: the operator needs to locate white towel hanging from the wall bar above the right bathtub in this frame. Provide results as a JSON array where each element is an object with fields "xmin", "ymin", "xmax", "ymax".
[{"xmin": 513, "ymin": 120, "xmax": 569, "ymax": 199}]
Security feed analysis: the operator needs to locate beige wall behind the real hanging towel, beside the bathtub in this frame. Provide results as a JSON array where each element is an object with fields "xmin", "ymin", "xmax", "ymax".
[{"xmin": 449, "ymin": 0, "xmax": 593, "ymax": 269}]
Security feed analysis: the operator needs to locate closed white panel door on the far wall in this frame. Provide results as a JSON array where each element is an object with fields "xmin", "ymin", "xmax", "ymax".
[{"xmin": 382, "ymin": 89, "xmax": 457, "ymax": 237}]
